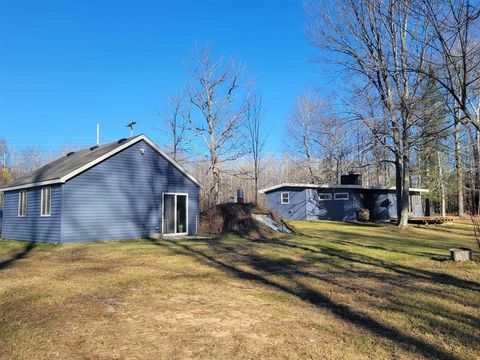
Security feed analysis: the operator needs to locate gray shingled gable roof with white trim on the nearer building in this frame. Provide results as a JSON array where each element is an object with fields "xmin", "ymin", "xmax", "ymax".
[{"xmin": 0, "ymin": 134, "xmax": 200, "ymax": 191}]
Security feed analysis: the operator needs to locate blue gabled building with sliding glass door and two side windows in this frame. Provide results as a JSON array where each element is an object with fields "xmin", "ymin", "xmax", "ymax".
[{"xmin": 0, "ymin": 135, "xmax": 200, "ymax": 243}]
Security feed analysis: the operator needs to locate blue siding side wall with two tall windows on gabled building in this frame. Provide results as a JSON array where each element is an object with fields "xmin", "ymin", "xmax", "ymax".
[{"xmin": 2, "ymin": 185, "xmax": 62, "ymax": 243}]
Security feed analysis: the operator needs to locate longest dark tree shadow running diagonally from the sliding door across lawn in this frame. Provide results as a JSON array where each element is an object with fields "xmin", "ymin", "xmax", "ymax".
[{"xmin": 151, "ymin": 239, "xmax": 468, "ymax": 360}]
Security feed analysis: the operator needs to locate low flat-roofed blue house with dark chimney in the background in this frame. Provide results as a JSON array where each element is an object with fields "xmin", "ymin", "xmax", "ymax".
[{"xmin": 260, "ymin": 174, "xmax": 428, "ymax": 221}]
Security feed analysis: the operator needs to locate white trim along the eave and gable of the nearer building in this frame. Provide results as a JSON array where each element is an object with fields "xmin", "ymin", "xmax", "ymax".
[{"xmin": 0, "ymin": 135, "xmax": 202, "ymax": 191}]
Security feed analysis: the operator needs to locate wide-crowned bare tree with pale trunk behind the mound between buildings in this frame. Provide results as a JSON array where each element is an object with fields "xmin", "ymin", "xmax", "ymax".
[{"xmin": 187, "ymin": 46, "xmax": 249, "ymax": 204}]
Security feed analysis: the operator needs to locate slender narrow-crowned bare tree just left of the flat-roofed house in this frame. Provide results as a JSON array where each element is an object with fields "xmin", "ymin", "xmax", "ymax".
[{"xmin": 245, "ymin": 94, "xmax": 267, "ymax": 206}]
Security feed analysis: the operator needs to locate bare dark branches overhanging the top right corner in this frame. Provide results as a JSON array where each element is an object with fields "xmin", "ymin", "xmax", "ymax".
[{"xmin": 417, "ymin": 0, "xmax": 480, "ymax": 131}]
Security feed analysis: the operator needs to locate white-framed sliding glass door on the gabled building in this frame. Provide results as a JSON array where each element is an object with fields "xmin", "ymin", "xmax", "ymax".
[{"xmin": 163, "ymin": 194, "xmax": 188, "ymax": 235}]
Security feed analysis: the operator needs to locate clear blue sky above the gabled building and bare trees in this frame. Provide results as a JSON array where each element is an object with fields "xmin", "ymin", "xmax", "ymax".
[{"xmin": 0, "ymin": 0, "xmax": 322, "ymax": 151}]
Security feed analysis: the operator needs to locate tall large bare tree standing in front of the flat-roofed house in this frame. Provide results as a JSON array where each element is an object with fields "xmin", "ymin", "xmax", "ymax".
[{"xmin": 306, "ymin": 0, "xmax": 432, "ymax": 227}]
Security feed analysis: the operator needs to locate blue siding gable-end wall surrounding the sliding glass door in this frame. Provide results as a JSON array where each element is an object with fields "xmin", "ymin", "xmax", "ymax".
[{"xmin": 62, "ymin": 141, "xmax": 199, "ymax": 242}]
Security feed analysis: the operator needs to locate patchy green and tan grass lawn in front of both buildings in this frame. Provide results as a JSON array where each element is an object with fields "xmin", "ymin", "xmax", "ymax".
[{"xmin": 0, "ymin": 221, "xmax": 480, "ymax": 359}]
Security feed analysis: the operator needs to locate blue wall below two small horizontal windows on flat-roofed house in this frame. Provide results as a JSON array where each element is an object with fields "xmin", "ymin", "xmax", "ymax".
[{"xmin": 307, "ymin": 188, "xmax": 364, "ymax": 221}]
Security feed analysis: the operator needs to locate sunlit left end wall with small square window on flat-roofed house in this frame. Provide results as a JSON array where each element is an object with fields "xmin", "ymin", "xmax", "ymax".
[{"xmin": 265, "ymin": 188, "xmax": 307, "ymax": 220}]
